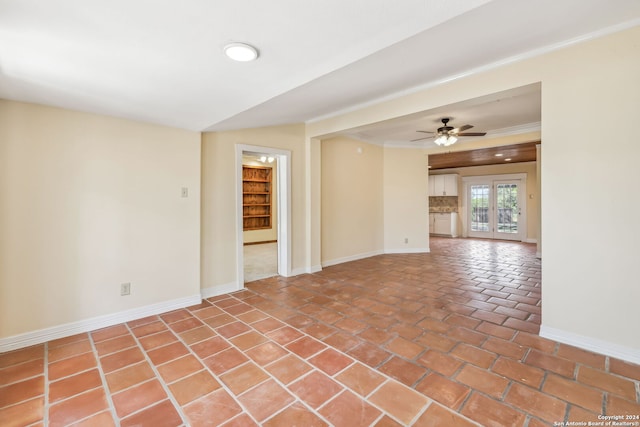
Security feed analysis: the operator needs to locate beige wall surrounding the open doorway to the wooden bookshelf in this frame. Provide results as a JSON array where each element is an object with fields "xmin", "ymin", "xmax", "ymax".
[{"xmin": 201, "ymin": 124, "xmax": 307, "ymax": 292}]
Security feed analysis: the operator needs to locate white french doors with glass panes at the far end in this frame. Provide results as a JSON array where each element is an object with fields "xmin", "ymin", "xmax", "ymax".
[{"xmin": 467, "ymin": 179, "xmax": 526, "ymax": 240}]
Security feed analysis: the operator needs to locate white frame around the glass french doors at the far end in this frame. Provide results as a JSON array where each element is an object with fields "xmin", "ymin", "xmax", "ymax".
[{"xmin": 460, "ymin": 173, "xmax": 527, "ymax": 242}]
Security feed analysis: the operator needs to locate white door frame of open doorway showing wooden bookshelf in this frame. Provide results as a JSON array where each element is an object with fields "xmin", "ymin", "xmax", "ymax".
[{"xmin": 236, "ymin": 144, "xmax": 291, "ymax": 290}]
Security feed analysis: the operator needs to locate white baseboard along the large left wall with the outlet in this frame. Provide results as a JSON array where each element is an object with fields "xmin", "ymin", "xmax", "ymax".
[{"xmin": 0, "ymin": 294, "xmax": 202, "ymax": 353}]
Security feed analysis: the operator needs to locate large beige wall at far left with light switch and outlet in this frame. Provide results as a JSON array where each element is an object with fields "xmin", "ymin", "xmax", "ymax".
[{"xmin": 0, "ymin": 100, "xmax": 200, "ymax": 338}]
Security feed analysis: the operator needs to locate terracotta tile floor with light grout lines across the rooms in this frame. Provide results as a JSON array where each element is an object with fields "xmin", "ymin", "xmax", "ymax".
[{"xmin": 0, "ymin": 239, "xmax": 640, "ymax": 427}]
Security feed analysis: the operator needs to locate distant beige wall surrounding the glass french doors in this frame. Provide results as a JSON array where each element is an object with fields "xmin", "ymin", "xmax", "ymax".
[{"xmin": 430, "ymin": 162, "xmax": 540, "ymax": 243}]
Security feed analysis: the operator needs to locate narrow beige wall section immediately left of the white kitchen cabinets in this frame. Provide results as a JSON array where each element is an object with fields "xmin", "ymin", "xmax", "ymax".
[{"xmin": 384, "ymin": 147, "xmax": 429, "ymax": 253}]
